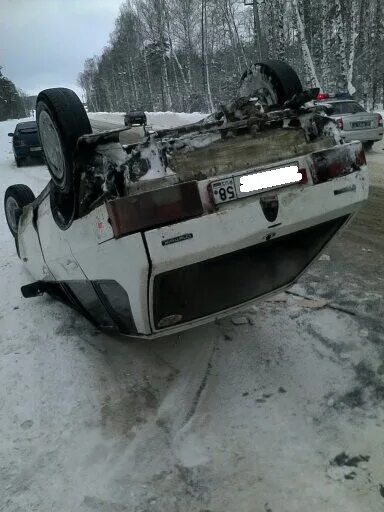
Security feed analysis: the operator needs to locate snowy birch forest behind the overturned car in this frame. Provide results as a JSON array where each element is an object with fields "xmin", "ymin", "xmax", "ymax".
[{"xmin": 79, "ymin": 0, "xmax": 384, "ymax": 112}]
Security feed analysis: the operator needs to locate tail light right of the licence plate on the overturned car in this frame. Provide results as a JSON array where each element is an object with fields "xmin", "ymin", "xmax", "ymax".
[{"xmin": 311, "ymin": 143, "xmax": 366, "ymax": 184}]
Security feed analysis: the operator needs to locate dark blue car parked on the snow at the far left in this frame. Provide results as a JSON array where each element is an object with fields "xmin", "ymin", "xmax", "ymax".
[{"xmin": 8, "ymin": 121, "xmax": 44, "ymax": 167}]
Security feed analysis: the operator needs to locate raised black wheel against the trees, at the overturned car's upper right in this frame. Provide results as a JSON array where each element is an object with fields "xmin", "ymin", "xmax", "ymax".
[{"xmin": 240, "ymin": 60, "xmax": 303, "ymax": 106}]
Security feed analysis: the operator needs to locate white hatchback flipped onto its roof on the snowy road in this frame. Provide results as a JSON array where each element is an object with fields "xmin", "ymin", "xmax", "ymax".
[{"xmin": 4, "ymin": 61, "xmax": 368, "ymax": 337}]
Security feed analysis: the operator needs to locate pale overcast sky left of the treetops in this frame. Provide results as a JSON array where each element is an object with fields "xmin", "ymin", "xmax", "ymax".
[{"xmin": 0, "ymin": 0, "xmax": 123, "ymax": 99}]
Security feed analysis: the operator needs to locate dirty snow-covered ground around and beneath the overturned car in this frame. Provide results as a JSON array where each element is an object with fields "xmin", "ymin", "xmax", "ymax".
[{"xmin": 0, "ymin": 116, "xmax": 384, "ymax": 512}]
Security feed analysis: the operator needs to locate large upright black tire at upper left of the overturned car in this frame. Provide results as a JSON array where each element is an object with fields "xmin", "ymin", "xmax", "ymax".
[{"xmin": 36, "ymin": 87, "xmax": 92, "ymax": 193}]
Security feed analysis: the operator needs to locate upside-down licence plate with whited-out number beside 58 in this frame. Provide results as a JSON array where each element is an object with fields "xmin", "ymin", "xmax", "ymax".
[{"xmin": 211, "ymin": 164, "xmax": 303, "ymax": 204}]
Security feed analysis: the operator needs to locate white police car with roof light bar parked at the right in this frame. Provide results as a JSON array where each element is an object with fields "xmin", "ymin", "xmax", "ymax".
[{"xmin": 318, "ymin": 93, "xmax": 384, "ymax": 149}]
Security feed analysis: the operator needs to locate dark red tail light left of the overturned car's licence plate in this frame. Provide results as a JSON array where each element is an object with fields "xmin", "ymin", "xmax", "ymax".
[{"xmin": 106, "ymin": 181, "xmax": 204, "ymax": 238}]
